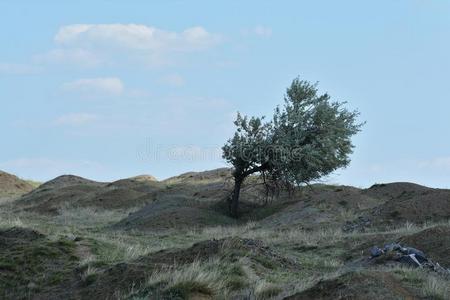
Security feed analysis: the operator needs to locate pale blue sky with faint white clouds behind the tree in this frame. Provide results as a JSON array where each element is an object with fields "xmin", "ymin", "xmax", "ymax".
[{"xmin": 0, "ymin": 0, "xmax": 450, "ymax": 187}]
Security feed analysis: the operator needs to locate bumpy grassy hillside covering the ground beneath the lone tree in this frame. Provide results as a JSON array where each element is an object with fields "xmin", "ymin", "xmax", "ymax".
[{"xmin": 0, "ymin": 169, "xmax": 450, "ymax": 299}]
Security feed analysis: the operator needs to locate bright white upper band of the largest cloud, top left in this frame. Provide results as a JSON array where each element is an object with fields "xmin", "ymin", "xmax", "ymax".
[{"xmin": 54, "ymin": 24, "xmax": 219, "ymax": 51}]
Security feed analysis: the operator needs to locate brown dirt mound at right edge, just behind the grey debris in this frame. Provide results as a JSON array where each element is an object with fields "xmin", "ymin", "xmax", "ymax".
[{"xmin": 400, "ymin": 226, "xmax": 450, "ymax": 268}]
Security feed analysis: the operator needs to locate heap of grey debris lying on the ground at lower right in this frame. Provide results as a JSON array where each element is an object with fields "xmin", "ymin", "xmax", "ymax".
[{"xmin": 370, "ymin": 243, "xmax": 450, "ymax": 276}]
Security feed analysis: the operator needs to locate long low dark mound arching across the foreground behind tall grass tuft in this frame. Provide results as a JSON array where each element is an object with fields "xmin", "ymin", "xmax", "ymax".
[{"xmin": 80, "ymin": 238, "xmax": 299, "ymax": 299}]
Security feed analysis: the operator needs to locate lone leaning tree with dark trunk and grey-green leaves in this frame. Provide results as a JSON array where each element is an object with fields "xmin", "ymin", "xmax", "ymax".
[{"xmin": 222, "ymin": 78, "xmax": 363, "ymax": 217}]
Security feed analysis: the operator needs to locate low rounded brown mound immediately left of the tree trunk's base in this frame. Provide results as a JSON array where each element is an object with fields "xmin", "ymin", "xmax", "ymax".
[{"xmin": 113, "ymin": 196, "xmax": 235, "ymax": 231}]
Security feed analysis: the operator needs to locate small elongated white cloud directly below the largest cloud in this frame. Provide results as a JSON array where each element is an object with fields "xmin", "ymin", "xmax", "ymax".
[{"xmin": 62, "ymin": 77, "xmax": 124, "ymax": 97}]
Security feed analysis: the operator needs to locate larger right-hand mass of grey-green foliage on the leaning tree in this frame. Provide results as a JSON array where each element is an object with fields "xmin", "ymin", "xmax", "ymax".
[{"xmin": 272, "ymin": 79, "xmax": 361, "ymax": 184}]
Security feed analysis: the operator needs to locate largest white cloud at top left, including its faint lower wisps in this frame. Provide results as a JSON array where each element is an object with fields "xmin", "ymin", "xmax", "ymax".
[{"xmin": 35, "ymin": 24, "xmax": 221, "ymax": 67}]
